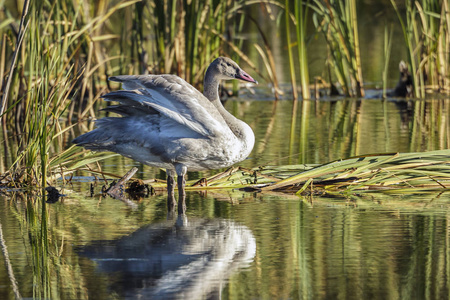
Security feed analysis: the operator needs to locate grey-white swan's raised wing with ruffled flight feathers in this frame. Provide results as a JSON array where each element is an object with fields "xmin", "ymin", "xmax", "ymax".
[{"xmin": 107, "ymin": 75, "xmax": 229, "ymax": 136}]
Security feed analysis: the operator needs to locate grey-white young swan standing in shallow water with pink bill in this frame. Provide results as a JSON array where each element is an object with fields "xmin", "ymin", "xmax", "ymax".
[{"xmin": 73, "ymin": 57, "xmax": 257, "ymax": 213}]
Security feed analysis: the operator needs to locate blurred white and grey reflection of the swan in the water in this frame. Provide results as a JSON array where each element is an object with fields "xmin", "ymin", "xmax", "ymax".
[{"xmin": 80, "ymin": 214, "xmax": 256, "ymax": 299}]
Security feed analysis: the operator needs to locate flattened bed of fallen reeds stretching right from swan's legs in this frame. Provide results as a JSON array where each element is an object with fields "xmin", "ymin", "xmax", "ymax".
[{"xmin": 146, "ymin": 150, "xmax": 450, "ymax": 195}]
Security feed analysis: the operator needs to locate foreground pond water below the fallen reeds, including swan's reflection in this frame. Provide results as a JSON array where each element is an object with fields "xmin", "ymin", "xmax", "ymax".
[{"xmin": 0, "ymin": 186, "xmax": 450, "ymax": 299}]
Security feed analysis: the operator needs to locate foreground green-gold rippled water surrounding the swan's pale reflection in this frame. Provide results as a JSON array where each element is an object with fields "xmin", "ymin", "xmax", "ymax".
[{"xmin": 0, "ymin": 186, "xmax": 450, "ymax": 299}]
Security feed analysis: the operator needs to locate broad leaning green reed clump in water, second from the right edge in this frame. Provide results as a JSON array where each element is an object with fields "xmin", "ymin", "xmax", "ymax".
[{"xmin": 311, "ymin": 0, "xmax": 364, "ymax": 97}]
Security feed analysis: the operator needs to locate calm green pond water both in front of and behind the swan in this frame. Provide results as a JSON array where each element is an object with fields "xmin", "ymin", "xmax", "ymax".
[{"xmin": 0, "ymin": 99, "xmax": 450, "ymax": 299}]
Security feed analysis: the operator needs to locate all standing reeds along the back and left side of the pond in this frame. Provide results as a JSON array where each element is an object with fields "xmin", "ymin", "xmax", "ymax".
[{"xmin": 0, "ymin": 0, "xmax": 450, "ymax": 187}]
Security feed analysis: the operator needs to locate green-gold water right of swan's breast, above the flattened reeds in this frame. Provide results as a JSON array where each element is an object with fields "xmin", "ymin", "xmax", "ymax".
[{"xmin": 227, "ymin": 99, "xmax": 450, "ymax": 167}]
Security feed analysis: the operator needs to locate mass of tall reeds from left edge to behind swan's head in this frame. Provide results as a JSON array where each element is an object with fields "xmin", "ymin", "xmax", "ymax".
[{"xmin": 0, "ymin": 0, "xmax": 262, "ymax": 187}]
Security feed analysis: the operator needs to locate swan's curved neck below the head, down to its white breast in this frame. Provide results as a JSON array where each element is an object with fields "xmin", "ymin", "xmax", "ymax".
[{"xmin": 203, "ymin": 73, "xmax": 255, "ymax": 156}]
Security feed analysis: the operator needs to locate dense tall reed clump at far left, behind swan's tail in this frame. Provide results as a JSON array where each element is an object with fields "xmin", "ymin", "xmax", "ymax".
[{"xmin": 2, "ymin": 1, "xmax": 136, "ymax": 187}]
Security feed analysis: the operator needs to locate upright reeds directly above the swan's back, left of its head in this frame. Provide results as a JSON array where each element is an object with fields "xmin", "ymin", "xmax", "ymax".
[{"xmin": 147, "ymin": 0, "xmax": 242, "ymax": 85}]
